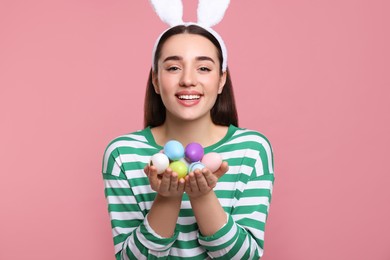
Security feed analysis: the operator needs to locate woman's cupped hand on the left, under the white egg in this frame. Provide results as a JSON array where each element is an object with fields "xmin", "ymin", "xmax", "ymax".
[{"xmin": 144, "ymin": 165, "xmax": 185, "ymax": 197}]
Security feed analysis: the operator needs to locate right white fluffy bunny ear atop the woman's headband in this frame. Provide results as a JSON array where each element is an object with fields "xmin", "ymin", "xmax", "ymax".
[{"xmin": 198, "ymin": 0, "xmax": 230, "ymax": 27}]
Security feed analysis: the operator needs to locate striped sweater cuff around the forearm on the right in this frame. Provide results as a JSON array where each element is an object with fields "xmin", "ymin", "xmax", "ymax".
[{"xmin": 198, "ymin": 213, "xmax": 239, "ymax": 252}]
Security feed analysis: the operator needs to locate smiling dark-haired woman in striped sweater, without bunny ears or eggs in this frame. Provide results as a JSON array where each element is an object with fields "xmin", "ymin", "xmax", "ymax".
[{"xmin": 103, "ymin": 25, "xmax": 274, "ymax": 259}]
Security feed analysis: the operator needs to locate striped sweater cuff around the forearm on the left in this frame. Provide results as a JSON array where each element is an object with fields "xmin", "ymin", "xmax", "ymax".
[{"xmin": 136, "ymin": 212, "xmax": 179, "ymax": 251}]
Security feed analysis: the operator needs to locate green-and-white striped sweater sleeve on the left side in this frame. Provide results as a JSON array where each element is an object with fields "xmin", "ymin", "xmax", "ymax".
[{"xmin": 103, "ymin": 146, "xmax": 178, "ymax": 259}]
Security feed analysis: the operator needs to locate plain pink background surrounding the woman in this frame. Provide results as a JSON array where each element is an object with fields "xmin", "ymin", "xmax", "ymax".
[{"xmin": 0, "ymin": 0, "xmax": 390, "ymax": 260}]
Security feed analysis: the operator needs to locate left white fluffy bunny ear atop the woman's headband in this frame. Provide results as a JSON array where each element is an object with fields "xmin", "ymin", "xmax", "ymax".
[{"xmin": 150, "ymin": 0, "xmax": 183, "ymax": 27}]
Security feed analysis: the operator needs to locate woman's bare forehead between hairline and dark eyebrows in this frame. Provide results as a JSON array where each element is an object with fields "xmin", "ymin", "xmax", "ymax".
[{"xmin": 161, "ymin": 33, "xmax": 217, "ymax": 58}]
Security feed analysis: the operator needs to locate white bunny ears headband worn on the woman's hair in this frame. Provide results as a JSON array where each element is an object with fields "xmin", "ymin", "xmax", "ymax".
[{"xmin": 150, "ymin": 0, "xmax": 230, "ymax": 72}]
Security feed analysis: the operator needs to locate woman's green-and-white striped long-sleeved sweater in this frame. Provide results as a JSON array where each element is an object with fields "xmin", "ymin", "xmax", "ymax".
[{"xmin": 103, "ymin": 125, "xmax": 274, "ymax": 259}]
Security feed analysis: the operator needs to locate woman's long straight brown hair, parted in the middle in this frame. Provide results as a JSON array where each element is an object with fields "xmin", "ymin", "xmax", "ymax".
[{"xmin": 144, "ymin": 24, "xmax": 238, "ymax": 127}]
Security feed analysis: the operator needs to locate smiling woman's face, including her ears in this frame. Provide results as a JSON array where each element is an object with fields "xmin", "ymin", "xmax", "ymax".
[{"xmin": 153, "ymin": 34, "xmax": 226, "ymax": 124}]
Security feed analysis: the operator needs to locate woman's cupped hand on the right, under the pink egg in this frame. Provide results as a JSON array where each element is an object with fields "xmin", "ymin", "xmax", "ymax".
[{"xmin": 184, "ymin": 162, "xmax": 229, "ymax": 198}]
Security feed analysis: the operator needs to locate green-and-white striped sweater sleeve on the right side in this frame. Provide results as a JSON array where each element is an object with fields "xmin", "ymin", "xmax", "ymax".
[{"xmin": 199, "ymin": 137, "xmax": 274, "ymax": 259}]
